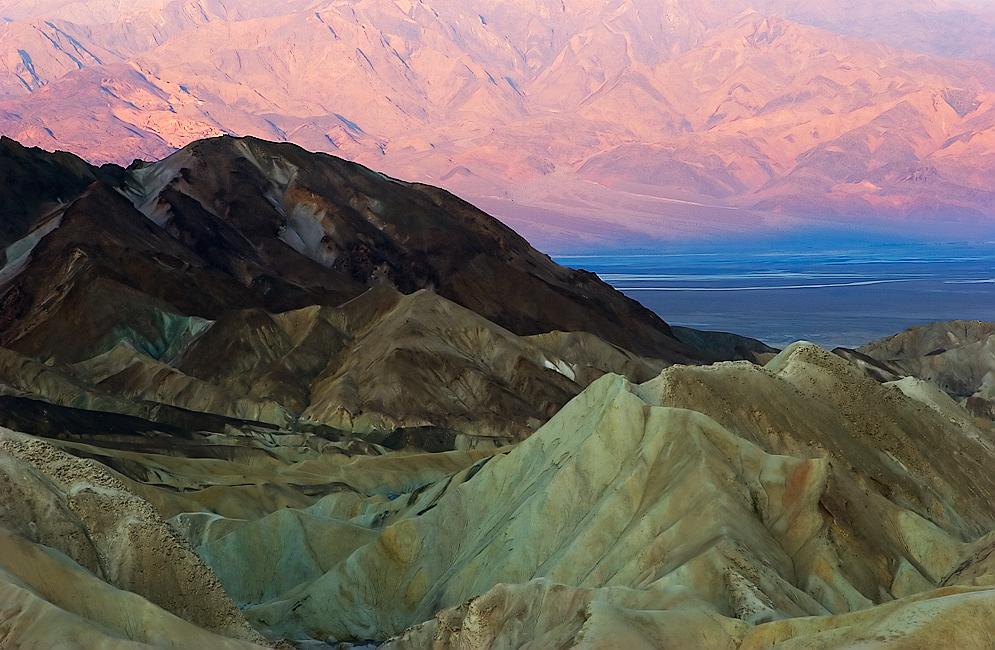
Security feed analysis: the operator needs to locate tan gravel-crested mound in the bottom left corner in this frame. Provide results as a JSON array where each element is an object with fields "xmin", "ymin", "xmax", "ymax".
[{"xmin": 0, "ymin": 430, "xmax": 262, "ymax": 648}]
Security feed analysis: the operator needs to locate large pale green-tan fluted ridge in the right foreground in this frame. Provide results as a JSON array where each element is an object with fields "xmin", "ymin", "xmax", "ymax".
[{"xmin": 83, "ymin": 344, "xmax": 995, "ymax": 649}]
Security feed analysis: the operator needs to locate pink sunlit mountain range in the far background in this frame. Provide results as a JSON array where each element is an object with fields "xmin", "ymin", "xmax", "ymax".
[{"xmin": 0, "ymin": 0, "xmax": 995, "ymax": 252}]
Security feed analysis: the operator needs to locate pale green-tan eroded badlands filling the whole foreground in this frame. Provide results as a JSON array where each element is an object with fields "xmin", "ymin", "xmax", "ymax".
[{"xmin": 2, "ymin": 344, "xmax": 995, "ymax": 650}]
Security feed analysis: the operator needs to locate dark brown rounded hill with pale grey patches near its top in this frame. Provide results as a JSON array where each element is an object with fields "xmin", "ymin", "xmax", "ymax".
[{"xmin": 0, "ymin": 137, "xmax": 710, "ymax": 362}]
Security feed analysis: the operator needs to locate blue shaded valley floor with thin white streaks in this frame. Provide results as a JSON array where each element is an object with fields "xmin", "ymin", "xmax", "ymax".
[{"xmin": 554, "ymin": 239, "xmax": 995, "ymax": 349}]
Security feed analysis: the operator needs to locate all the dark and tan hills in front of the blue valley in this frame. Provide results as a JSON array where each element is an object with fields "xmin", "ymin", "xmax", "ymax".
[{"xmin": 0, "ymin": 137, "xmax": 995, "ymax": 650}]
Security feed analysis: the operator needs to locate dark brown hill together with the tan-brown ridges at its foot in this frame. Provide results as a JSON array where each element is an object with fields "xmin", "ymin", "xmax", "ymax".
[{"xmin": 0, "ymin": 131, "xmax": 748, "ymax": 450}]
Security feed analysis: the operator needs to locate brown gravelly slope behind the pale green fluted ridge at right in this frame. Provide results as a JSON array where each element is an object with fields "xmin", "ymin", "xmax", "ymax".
[{"xmin": 640, "ymin": 343, "xmax": 995, "ymax": 541}]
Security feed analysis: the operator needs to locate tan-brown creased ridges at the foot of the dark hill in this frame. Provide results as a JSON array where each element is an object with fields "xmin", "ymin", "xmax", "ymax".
[{"xmin": 44, "ymin": 287, "xmax": 667, "ymax": 451}]
